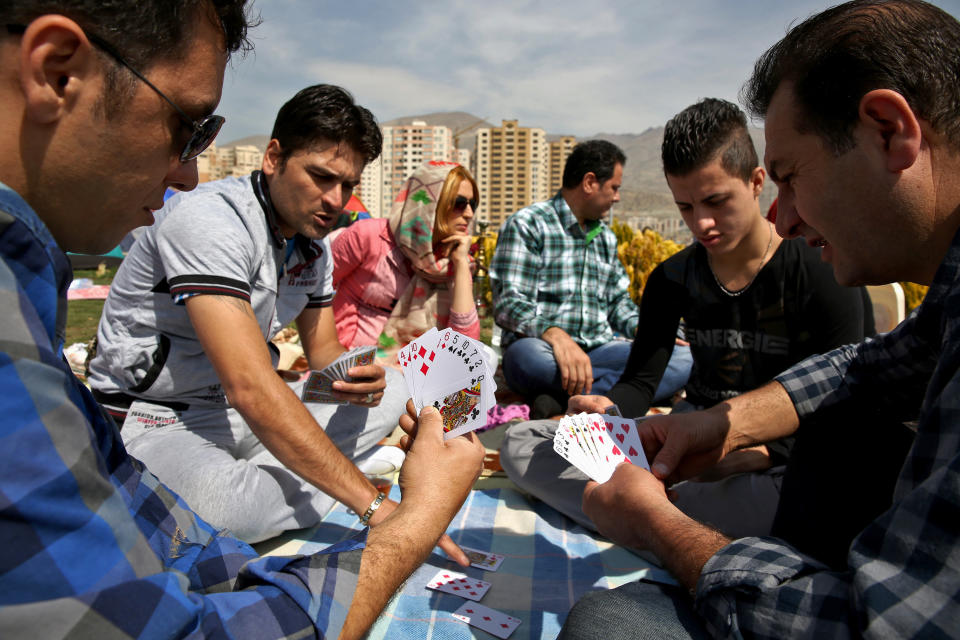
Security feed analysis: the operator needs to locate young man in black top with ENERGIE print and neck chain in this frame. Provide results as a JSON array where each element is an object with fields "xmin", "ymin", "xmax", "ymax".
[{"xmin": 501, "ymin": 98, "xmax": 873, "ymax": 537}]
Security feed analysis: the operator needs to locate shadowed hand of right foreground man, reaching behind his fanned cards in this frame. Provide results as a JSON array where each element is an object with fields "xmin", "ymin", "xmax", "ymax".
[{"xmin": 637, "ymin": 410, "xmax": 728, "ymax": 484}]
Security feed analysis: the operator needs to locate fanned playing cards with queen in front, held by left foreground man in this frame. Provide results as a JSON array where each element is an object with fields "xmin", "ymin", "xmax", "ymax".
[{"xmin": 397, "ymin": 329, "xmax": 497, "ymax": 439}]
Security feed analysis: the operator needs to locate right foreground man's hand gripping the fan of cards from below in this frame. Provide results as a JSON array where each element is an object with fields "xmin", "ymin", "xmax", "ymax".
[{"xmin": 582, "ymin": 462, "xmax": 676, "ymax": 549}]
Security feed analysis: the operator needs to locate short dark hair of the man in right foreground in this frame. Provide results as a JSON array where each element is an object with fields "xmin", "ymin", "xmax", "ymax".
[{"xmin": 741, "ymin": 0, "xmax": 960, "ymax": 155}]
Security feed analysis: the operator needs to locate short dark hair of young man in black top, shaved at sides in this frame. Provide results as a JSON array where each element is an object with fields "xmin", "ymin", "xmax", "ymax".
[{"xmin": 660, "ymin": 98, "xmax": 760, "ymax": 182}]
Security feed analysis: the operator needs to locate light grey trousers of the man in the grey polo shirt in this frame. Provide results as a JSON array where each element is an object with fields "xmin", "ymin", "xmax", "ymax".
[{"xmin": 120, "ymin": 369, "xmax": 409, "ymax": 543}]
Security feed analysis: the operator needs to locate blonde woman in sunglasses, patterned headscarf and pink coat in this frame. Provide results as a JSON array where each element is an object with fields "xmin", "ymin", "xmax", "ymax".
[{"xmin": 333, "ymin": 161, "xmax": 480, "ymax": 348}]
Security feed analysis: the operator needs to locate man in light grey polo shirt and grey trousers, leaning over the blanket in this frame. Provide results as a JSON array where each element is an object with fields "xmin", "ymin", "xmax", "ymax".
[{"xmin": 90, "ymin": 85, "xmax": 466, "ymax": 564}]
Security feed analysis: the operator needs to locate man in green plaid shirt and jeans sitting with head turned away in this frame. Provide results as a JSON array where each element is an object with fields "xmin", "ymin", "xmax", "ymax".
[{"xmin": 490, "ymin": 140, "xmax": 656, "ymax": 412}]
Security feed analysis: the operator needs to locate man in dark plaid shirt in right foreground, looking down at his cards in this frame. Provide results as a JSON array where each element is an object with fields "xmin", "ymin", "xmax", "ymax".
[{"xmin": 562, "ymin": 0, "xmax": 960, "ymax": 639}]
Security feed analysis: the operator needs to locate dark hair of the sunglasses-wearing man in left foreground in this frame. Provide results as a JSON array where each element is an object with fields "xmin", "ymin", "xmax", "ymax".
[{"xmin": 0, "ymin": 0, "xmax": 259, "ymax": 118}]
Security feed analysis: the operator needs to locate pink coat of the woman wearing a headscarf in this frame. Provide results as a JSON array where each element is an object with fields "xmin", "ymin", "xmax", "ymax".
[{"xmin": 332, "ymin": 218, "xmax": 480, "ymax": 348}]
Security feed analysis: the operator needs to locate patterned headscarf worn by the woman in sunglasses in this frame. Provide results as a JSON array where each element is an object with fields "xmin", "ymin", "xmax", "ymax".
[{"xmin": 384, "ymin": 160, "xmax": 472, "ymax": 344}]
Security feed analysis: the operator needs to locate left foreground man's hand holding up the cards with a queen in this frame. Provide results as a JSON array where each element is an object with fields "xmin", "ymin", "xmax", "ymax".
[{"xmin": 399, "ymin": 400, "xmax": 485, "ymax": 567}]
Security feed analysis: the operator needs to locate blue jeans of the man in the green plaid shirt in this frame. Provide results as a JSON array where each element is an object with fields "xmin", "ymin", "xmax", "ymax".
[{"xmin": 503, "ymin": 338, "xmax": 693, "ymax": 403}]
